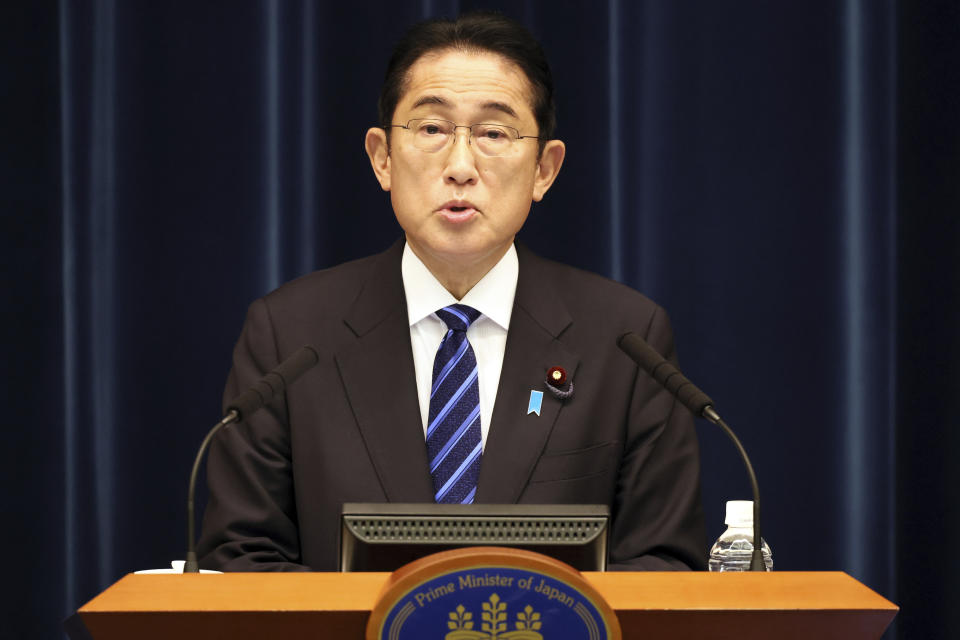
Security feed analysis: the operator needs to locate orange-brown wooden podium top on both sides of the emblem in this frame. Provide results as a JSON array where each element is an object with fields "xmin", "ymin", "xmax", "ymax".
[{"xmin": 79, "ymin": 572, "xmax": 898, "ymax": 640}]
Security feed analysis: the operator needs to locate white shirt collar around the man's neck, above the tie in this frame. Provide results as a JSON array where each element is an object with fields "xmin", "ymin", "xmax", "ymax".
[{"xmin": 400, "ymin": 243, "xmax": 520, "ymax": 330}]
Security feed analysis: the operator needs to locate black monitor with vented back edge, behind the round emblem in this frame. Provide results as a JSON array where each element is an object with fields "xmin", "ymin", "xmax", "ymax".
[{"xmin": 340, "ymin": 503, "xmax": 610, "ymax": 571}]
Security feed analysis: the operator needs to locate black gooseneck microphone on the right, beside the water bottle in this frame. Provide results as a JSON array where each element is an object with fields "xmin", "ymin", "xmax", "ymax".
[{"xmin": 617, "ymin": 333, "xmax": 766, "ymax": 571}]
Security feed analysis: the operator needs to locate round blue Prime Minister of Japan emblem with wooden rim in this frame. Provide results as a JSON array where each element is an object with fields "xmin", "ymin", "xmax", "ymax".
[{"xmin": 367, "ymin": 547, "xmax": 621, "ymax": 640}]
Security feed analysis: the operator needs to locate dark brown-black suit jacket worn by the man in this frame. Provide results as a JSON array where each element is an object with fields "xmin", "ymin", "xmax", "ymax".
[{"xmin": 199, "ymin": 240, "xmax": 707, "ymax": 571}]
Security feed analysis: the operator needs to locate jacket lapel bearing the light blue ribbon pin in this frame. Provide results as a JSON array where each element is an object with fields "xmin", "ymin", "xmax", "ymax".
[{"xmin": 476, "ymin": 245, "xmax": 580, "ymax": 503}]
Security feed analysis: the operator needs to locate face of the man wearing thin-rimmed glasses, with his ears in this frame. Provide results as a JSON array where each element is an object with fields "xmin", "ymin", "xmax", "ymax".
[{"xmin": 367, "ymin": 51, "xmax": 563, "ymax": 276}]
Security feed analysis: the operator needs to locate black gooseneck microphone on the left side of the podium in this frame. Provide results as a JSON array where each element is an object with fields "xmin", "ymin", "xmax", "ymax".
[{"xmin": 183, "ymin": 345, "xmax": 320, "ymax": 573}]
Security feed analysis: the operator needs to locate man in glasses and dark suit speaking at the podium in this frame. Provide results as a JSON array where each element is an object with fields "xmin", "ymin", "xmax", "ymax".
[{"xmin": 200, "ymin": 14, "xmax": 706, "ymax": 570}]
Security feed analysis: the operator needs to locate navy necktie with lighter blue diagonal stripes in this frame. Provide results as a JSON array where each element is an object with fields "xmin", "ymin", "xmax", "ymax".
[{"xmin": 427, "ymin": 304, "xmax": 482, "ymax": 504}]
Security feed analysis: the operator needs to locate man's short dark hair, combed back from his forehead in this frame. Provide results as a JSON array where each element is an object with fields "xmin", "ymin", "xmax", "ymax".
[{"xmin": 378, "ymin": 11, "xmax": 557, "ymax": 141}]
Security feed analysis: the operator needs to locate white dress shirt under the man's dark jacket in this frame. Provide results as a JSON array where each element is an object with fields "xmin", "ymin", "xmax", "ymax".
[{"xmin": 400, "ymin": 244, "xmax": 520, "ymax": 447}]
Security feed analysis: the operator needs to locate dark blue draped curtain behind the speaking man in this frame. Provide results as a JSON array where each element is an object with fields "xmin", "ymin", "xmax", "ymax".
[{"xmin": 0, "ymin": 0, "xmax": 960, "ymax": 638}]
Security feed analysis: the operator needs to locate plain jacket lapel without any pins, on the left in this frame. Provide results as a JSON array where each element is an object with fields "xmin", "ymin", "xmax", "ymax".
[{"xmin": 336, "ymin": 239, "xmax": 433, "ymax": 502}]
